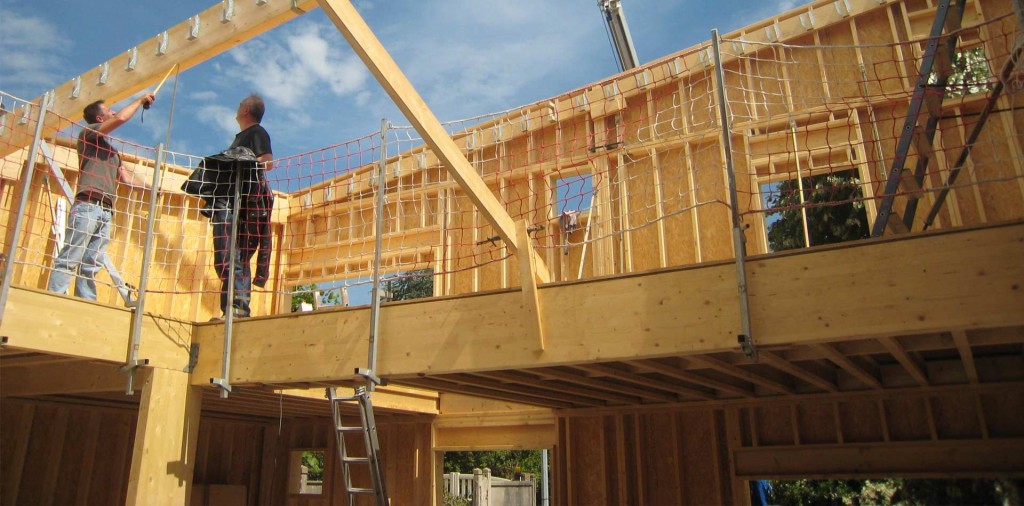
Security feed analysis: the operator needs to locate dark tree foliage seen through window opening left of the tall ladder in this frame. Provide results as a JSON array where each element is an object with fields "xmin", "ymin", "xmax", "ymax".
[{"xmin": 767, "ymin": 171, "xmax": 870, "ymax": 251}]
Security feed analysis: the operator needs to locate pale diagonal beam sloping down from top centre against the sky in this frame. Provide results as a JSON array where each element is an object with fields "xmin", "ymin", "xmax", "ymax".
[{"xmin": 317, "ymin": 0, "xmax": 550, "ymax": 282}]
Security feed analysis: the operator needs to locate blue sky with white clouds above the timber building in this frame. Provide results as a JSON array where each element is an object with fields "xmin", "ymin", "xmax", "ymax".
[{"xmin": 0, "ymin": 0, "xmax": 790, "ymax": 157}]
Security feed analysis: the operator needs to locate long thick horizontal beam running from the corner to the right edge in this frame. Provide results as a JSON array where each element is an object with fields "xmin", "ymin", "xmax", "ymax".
[{"xmin": 190, "ymin": 223, "xmax": 1024, "ymax": 384}]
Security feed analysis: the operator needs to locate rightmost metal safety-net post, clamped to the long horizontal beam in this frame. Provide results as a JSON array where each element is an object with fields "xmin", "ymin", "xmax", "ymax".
[{"xmin": 711, "ymin": 30, "xmax": 758, "ymax": 361}]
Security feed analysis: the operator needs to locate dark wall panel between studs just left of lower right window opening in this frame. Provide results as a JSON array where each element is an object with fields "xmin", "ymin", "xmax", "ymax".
[{"xmin": 677, "ymin": 411, "xmax": 723, "ymax": 504}]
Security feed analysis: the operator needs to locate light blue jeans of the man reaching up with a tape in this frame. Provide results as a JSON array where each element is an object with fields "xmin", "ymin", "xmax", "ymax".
[{"xmin": 47, "ymin": 202, "xmax": 111, "ymax": 300}]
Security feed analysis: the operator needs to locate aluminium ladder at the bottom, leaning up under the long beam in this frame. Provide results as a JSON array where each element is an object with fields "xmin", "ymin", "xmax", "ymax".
[{"xmin": 328, "ymin": 386, "xmax": 388, "ymax": 506}]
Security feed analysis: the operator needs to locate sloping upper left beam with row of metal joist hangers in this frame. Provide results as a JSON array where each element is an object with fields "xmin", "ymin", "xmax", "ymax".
[{"xmin": 0, "ymin": 0, "xmax": 316, "ymax": 158}]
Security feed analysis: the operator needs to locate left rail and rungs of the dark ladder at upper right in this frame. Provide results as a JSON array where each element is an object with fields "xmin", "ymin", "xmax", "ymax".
[{"xmin": 871, "ymin": 0, "xmax": 967, "ymax": 237}]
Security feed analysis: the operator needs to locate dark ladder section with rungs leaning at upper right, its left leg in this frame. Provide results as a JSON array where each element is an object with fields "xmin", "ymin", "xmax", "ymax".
[{"xmin": 871, "ymin": 0, "xmax": 967, "ymax": 238}]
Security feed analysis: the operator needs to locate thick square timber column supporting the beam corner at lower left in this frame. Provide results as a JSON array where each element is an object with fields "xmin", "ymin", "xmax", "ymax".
[{"xmin": 126, "ymin": 369, "xmax": 203, "ymax": 505}]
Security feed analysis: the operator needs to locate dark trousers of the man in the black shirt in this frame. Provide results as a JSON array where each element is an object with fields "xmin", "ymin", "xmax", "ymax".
[{"xmin": 210, "ymin": 199, "xmax": 256, "ymax": 317}]
